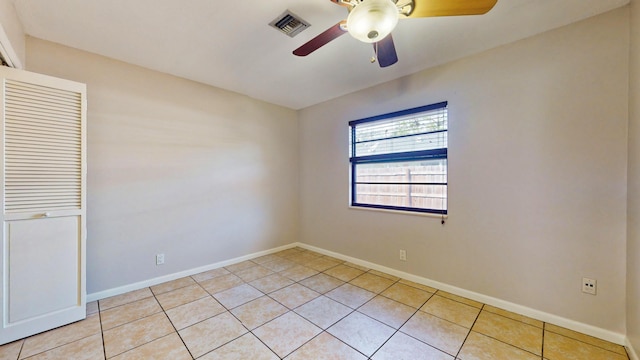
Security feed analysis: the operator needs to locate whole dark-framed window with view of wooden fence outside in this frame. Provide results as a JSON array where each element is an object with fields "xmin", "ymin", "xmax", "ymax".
[{"xmin": 349, "ymin": 102, "xmax": 448, "ymax": 215}]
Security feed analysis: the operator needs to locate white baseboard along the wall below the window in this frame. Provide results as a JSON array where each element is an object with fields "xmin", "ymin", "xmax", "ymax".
[{"xmin": 295, "ymin": 243, "xmax": 628, "ymax": 346}]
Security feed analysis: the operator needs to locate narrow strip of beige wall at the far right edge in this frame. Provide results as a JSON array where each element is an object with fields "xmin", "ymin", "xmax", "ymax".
[{"xmin": 627, "ymin": 0, "xmax": 640, "ymax": 350}]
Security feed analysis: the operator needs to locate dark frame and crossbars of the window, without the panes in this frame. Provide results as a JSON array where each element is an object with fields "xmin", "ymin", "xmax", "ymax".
[{"xmin": 349, "ymin": 101, "xmax": 449, "ymax": 216}]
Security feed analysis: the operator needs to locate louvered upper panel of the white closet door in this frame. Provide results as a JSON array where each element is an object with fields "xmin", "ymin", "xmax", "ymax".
[{"xmin": 4, "ymin": 80, "xmax": 82, "ymax": 213}]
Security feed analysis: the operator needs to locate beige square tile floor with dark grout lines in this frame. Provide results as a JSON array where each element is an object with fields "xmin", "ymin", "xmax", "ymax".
[{"xmin": 0, "ymin": 248, "xmax": 628, "ymax": 360}]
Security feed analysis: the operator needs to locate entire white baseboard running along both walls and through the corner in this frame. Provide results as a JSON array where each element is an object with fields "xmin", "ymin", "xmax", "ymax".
[{"xmin": 87, "ymin": 243, "xmax": 628, "ymax": 348}]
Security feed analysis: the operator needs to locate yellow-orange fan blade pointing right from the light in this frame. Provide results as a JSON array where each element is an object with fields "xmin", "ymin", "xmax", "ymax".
[{"xmin": 408, "ymin": 0, "xmax": 498, "ymax": 18}]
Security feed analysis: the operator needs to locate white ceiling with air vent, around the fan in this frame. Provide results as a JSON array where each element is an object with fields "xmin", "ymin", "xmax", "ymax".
[{"xmin": 15, "ymin": 0, "xmax": 629, "ymax": 109}]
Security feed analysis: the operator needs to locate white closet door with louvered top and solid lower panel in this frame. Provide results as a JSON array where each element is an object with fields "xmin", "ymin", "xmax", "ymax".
[{"xmin": 0, "ymin": 68, "xmax": 86, "ymax": 343}]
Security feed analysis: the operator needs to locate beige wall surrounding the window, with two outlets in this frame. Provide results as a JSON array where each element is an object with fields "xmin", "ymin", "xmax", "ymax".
[{"xmin": 299, "ymin": 8, "xmax": 629, "ymax": 334}]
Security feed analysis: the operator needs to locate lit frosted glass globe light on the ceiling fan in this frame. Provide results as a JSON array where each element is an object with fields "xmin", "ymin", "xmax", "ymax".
[{"xmin": 347, "ymin": 0, "xmax": 398, "ymax": 43}]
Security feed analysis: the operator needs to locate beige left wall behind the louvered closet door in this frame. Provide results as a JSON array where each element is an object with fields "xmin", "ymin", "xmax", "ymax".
[{"xmin": 22, "ymin": 38, "xmax": 298, "ymax": 294}]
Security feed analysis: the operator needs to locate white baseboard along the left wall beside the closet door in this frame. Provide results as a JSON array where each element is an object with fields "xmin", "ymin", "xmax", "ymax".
[{"xmin": 87, "ymin": 243, "xmax": 297, "ymax": 302}]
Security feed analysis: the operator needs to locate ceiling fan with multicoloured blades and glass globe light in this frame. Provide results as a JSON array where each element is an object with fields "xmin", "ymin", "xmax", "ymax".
[{"xmin": 293, "ymin": 0, "xmax": 498, "ymax": 67}]
